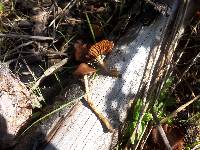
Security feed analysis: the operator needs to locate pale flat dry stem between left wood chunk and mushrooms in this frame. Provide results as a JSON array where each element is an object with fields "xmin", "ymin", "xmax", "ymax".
[{"xmin": 31, "ymin": 58, "xmax": 68, "ymax": 90}]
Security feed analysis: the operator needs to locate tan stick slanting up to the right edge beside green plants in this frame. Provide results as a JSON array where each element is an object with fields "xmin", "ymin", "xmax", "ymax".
[{"xmin": 160, "ymin": 95, "xmax": 200, "ymax": 124}]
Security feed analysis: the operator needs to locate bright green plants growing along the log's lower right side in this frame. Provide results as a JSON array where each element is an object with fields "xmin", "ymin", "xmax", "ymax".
[{"xmin": 118, "ymin": 78, "xmax": 176, "ymax": 149}]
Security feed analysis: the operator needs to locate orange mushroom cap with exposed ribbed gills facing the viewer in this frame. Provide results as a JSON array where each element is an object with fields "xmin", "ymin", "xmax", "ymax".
[{"xmin": 88, "ymin": 40, "xmax": 114, "ymax": 59}]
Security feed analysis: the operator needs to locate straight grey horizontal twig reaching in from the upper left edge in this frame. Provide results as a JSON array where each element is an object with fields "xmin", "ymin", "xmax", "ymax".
[{"xmin": 0, "ymin": 33, "xmax": 53, "ymax": 41}]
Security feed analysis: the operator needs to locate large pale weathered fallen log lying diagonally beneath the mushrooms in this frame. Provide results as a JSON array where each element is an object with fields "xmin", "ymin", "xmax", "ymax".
[{"xmin": 12, "ymin": 0, "xmax": 200, "ymax": 150}]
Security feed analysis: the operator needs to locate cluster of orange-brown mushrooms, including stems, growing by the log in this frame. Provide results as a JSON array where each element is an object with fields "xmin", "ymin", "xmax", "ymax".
[{"xmin": 74, "ymin": 40, "xmax": 114, "ymax": 132}]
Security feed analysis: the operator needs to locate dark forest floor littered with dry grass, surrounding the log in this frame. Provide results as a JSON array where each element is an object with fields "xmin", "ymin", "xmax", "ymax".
[{"xmin": 0, "ymin": 0, "xmax": 200, "ymax": 149}]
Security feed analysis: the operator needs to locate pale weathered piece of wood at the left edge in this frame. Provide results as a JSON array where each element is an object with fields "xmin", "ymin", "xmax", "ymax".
[{"xmin": 0, "ymin": 63, "xmax": 36, "ymax": 149}]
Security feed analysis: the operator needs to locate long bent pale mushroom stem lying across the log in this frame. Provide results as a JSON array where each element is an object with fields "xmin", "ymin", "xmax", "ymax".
[{"xmin": 84, "ymin": 75, "xmax": 114, "ymax": 132}]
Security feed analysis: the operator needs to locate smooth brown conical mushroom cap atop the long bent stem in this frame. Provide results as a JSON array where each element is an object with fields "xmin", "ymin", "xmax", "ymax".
[{"xmin": 73, "ymin": 63, "xmax": 96, "ymax": 76}]
